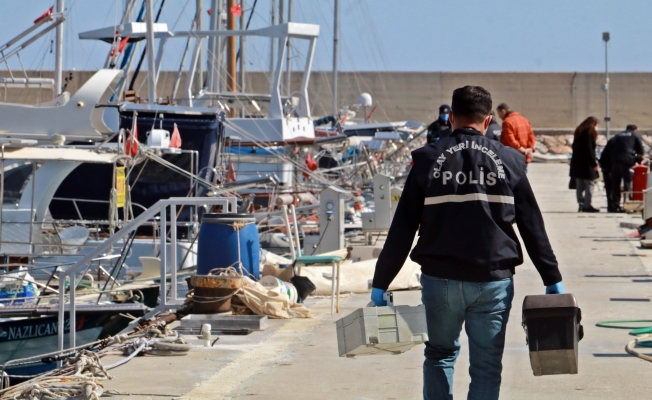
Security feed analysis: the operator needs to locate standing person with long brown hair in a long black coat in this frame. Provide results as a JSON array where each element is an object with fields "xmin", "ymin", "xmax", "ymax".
[{"xmin": 570, "ymin": 117, "xmax": 600, "ymax": 212}]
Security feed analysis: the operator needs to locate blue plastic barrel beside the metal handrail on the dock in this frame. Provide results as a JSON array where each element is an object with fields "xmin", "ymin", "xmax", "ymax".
[{"xmin": 197, "ymin": 214, "xmax": 260, "ymax": 279}]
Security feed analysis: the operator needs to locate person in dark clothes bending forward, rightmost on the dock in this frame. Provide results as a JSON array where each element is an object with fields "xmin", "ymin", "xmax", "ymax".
[{"xmin": 609, "ymin": 125, "xmax": 643, "ymax": 212}]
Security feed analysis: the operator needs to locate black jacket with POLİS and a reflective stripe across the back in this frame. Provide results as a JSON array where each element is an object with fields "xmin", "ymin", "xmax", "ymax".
[{"xmin": 373, "ymin": 129, "xmax": 561, "ymax": 290}]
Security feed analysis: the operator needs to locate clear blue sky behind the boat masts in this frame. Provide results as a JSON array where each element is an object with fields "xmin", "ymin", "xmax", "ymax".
[{"xmin": 0, "ymin": 0, "xmax": 652, "ymax": 72}]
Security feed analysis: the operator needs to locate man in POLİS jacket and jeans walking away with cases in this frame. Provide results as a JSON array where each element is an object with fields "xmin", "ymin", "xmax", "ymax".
[{"xmin": 371, "ymin": 86, "xmax": 563, "ymax": 400}]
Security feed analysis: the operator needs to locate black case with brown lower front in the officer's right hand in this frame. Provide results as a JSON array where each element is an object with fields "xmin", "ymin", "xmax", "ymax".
[{"xmin": 523, "ymin": 294, "xmax": 584, "ymax": 376}]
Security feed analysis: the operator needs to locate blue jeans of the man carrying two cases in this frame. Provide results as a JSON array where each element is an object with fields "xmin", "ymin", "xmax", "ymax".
[{"xmin": 421, "ymin": 274, "xmax": 514, "ymax": 400}]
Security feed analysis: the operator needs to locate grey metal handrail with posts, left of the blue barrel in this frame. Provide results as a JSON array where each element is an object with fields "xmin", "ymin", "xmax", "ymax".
[{"xmin": 57, "ymin": 197, "xmax": 237, "ymax": 351}]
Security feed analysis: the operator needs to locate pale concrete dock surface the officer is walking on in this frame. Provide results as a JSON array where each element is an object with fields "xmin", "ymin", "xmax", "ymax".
[{"xmin": 105, "ymin": 164, "xmax": 652, "ymax": 400}]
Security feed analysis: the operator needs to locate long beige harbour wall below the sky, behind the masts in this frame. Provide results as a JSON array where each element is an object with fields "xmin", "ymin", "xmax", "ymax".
[{"xmin": 0, "ymin": 71, "xmax": 652, "ymax": 131}]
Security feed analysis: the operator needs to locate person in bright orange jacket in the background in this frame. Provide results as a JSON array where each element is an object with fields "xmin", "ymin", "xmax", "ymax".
[{"xmin": 496, "ymin": 103, "xmax": 537, "ymax": 163}]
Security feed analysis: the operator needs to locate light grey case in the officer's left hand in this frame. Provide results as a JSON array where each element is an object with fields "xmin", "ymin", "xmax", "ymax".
[{"xmin": 335, "ymin": 304, "xmax": 428, "ymax": 357}]
